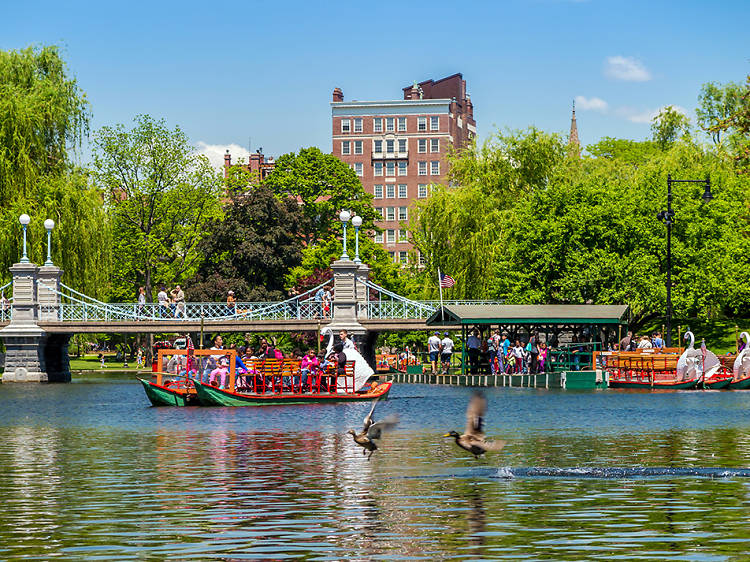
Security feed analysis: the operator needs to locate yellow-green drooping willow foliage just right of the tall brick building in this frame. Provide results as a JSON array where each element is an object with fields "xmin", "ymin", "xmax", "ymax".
[{"xmin": 410, "ymin": 127, "xmax": 566, "ymax": 299}]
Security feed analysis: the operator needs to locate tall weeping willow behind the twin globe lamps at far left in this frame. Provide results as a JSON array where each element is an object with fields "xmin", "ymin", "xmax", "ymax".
[{"xmin": 0, "ymin": 46, "xmax": 108, "ymax": 294}]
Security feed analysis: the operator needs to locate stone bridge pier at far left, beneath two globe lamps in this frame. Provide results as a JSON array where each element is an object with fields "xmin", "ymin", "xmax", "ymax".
[{"xmin": 0, "ymin": 263, "xmax": 71, "ymax": 383}]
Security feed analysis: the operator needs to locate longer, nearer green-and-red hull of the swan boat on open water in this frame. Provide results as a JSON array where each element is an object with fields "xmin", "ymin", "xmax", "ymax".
[{"xmin": 195, "ymin": 382, "xmax": 393, "ymax": 406}]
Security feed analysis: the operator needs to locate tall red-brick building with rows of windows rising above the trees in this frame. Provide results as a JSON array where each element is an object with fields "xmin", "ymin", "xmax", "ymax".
[{"xmin": 331, "ymin": 74, "xmax": 476, "ymax": 263}]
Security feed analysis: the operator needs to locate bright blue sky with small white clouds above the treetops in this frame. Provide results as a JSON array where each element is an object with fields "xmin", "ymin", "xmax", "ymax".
[{"xmin": 0, "ymin": 0, "xmax": 750, "ymax": 167}]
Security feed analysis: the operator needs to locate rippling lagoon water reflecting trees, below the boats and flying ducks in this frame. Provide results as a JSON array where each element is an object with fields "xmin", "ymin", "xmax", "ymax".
[{"xmin": 0, "ymin": 377, "xmax": 750, "ymax": 561}]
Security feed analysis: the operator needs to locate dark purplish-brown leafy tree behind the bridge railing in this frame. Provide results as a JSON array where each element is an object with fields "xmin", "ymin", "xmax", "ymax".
[{"xmin": 187, "ymin": 179, "xmax": 303, "ymax": 301}]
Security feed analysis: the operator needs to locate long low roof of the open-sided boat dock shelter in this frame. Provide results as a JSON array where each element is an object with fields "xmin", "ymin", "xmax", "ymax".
[{"xmin": 426, "ymin": 304, "xmax": 628, "ymax": 326}]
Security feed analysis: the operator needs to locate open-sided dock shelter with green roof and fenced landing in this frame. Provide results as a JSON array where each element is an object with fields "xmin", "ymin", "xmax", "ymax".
[{"xmin": 394, "ymin": 304, "xmax": 629, "ymax": 388}]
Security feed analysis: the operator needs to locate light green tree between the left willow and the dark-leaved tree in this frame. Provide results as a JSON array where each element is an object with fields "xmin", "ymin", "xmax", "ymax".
[{"xmin": 94, "ymin": 115, "xmax": 223, "ymax": 302}]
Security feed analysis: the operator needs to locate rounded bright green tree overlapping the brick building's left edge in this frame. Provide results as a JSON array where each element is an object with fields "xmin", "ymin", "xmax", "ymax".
[{"xmin": 265, "ymin": 147, "xmax": 382, "ymax": 246}]
